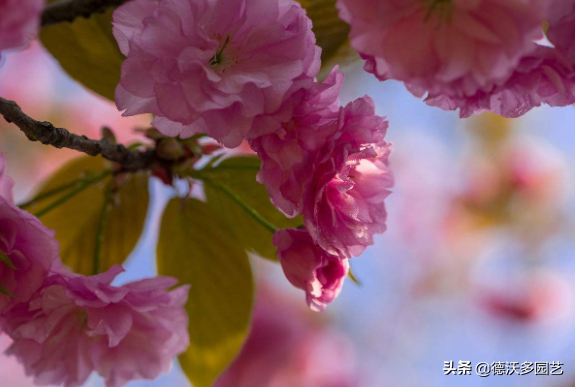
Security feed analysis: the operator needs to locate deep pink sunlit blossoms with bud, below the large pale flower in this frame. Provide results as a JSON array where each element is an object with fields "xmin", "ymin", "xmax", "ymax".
[{"xmin": 254, "ymin": 84, "xmax": 393, "ymax": 311}]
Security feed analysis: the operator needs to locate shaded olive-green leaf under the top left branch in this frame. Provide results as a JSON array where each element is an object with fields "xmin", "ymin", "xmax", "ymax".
[{"xmin": 40, "ymin": 0, "xmax": 124, "ymax": 101}]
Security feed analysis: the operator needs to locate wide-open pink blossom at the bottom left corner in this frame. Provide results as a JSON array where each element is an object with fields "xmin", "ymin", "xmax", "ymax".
[{"xmin": 0, "ymin": 266, "xmax": 189, "ymax": 387}]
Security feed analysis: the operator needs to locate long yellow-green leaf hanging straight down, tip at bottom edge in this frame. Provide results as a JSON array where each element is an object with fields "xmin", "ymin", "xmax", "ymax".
[{"xmin": 157, "ymin": 199, "xmax": 254, "ymax": 387}]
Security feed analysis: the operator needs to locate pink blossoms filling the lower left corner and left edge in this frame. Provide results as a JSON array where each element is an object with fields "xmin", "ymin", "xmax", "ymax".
[{"xmin": 0, "ymin": 157, "xmax": 189, "ymax": 387}]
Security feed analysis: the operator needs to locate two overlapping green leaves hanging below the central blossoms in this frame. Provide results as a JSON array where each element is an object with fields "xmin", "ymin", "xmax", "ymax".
[{"xmin": 158, "ymin": 156, "xmax": 308, "ymax": 387}]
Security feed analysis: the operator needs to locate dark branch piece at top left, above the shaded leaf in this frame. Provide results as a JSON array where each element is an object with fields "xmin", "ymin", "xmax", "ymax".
[{"xmin": 42, "ymin": 0, "xmax": 128, "ymax": 27}]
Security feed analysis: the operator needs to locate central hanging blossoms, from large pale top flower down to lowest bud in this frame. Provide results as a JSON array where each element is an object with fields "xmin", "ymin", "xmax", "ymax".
[{"xmin": 114, "ymin": 0, "xmax": 393, "ymax": 310}]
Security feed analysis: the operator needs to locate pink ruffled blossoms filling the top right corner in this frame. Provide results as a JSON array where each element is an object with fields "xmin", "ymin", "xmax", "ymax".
[{"xmin": 338, "ymin": 0, "xmax": 575, "ymax": 117}]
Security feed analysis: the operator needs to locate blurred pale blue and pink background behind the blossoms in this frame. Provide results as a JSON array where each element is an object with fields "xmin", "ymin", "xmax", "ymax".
[{"xmin": 0, "ymin": 44, "xmax": 575, "ymax": 387}]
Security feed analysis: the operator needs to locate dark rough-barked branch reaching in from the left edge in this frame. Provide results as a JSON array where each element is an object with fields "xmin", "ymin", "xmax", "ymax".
[{"xmin": 0, "ymin": 97, "xmax": 160, "ymax": 171}]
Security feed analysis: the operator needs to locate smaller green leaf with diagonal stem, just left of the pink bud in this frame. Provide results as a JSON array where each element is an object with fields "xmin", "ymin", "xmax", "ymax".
[{"xmin": 201, "ymin": 156, "xmax": 303, "ymax": 260}]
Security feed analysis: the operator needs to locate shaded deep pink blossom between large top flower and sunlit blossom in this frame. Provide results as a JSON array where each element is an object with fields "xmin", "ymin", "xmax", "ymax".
[{"xmin": 250, "ymin": 68, "xmax": 344, "ymax": 217}]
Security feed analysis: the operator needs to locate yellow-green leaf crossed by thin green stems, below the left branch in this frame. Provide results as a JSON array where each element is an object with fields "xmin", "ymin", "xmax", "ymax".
[{"xmin": 26, "ymin": 157, "xmax": 149, "ymax": 275}]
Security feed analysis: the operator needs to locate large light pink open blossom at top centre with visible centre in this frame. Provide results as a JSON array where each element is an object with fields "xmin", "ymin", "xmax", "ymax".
[{"xmin": 114, "ymin": 0, "xmax": 320, "ymax": 147}]
